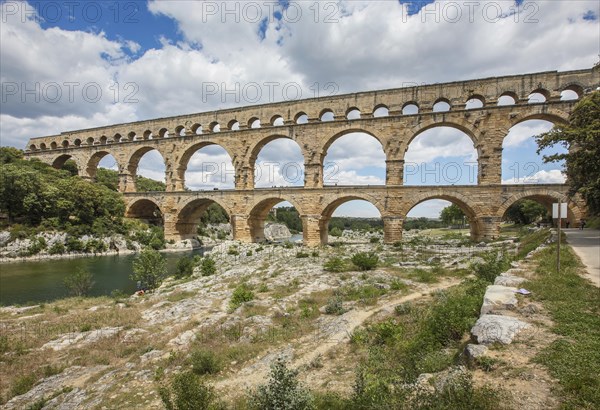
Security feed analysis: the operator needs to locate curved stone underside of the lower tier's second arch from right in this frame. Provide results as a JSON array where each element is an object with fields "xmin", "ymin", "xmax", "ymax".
[{"xmin": 400, "ymin": 192, "xmax": 485, "ymax": 240}]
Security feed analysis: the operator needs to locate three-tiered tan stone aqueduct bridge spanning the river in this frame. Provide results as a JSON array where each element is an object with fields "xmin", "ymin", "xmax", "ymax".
[{"xmin": 26, "ymin": 67, "xmax": 600, "ymax": 246}]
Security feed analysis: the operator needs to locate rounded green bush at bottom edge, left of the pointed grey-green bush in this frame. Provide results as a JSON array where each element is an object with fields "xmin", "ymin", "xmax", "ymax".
[{"xmin": 158, "ymin": 371, "xmax": 216, "ymax": 410}]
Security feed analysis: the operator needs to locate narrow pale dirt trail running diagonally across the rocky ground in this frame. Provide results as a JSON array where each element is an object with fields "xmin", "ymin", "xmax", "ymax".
[{"xmin": 215, "ymin": 279, "xmax": 460, "ymax": 392}]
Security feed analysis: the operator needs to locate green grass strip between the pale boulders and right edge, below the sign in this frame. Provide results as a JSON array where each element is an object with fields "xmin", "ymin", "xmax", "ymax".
[{"xmin": 524, "ymin": 245, "xmax": 600, "ymax": 408}]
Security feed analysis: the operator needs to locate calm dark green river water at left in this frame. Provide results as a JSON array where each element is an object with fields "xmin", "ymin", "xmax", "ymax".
[{"xmin": 0, "ymin": 250, "xmax": 202, "ymax": 305}]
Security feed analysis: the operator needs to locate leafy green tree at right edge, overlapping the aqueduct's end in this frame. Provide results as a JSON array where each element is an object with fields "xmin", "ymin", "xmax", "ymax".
[{"xmin": 536, "ymin": 91, "xmax": 600, "ymax": 215}]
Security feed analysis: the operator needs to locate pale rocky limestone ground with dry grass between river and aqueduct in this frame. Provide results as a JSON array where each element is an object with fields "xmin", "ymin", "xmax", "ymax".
[{"xmin": 0, "ymin": 232, "xmax": 564, "ymax": 409}]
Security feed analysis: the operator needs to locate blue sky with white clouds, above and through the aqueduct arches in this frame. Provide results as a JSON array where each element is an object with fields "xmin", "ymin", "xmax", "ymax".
[{"xmin": 0, "ymin": 0, "xmax": 600, "ymax": 216}]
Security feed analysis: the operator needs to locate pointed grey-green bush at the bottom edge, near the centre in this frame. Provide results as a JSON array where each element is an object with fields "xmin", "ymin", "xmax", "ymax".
[{"xmin": 248, "ymin": 357, "xmax": 314, "ymax": 410}]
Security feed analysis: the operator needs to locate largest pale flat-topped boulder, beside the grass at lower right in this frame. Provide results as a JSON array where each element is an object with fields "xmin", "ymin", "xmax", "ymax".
[{"xmin": 471, "ymin": 315, "xmax": 531, "ymax": 345}]
